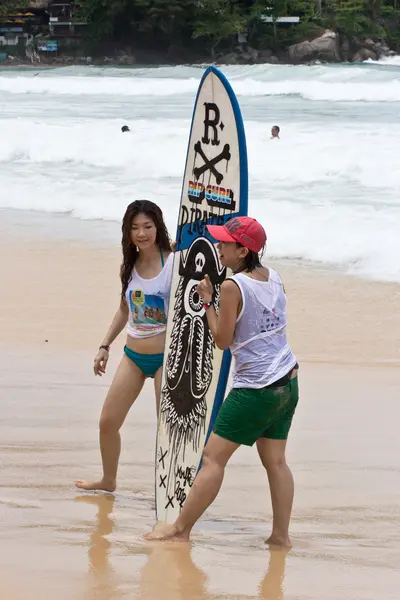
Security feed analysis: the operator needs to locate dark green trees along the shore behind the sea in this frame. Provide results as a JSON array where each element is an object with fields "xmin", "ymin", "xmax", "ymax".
[{"xmin": 74, "ymin": 0, "xmax": 400, "ymax": 50}]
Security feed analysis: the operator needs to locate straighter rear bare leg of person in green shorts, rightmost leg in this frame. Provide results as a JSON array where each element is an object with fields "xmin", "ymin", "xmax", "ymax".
[{"xmin": 257, "ymin": 438, "xmax": 294, "ymax": 548}]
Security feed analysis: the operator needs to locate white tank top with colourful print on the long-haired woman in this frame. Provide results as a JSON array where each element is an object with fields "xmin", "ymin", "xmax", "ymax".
[{"xmin": 125, "ymin": 252, "xmax": 174, "ymax": 339}]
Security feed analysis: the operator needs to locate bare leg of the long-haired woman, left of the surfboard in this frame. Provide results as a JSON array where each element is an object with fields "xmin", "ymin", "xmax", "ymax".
[{"xmin": 75, "ymin": 355, "xmax": 145, "ymax": 492}]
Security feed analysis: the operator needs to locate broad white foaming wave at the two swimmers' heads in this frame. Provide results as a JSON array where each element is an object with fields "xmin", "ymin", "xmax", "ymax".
[{"xmin": 0, "ymin": 116, "xmax": 400, "ymax": 189}]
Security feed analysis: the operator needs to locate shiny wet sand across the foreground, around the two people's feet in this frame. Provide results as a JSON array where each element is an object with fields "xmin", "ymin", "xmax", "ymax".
[{"xmin": 0, "ymin": 349, "xmax": 400, "ymax": 600}]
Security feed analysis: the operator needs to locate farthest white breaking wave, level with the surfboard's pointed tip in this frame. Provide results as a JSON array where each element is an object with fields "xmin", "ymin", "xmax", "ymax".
[{"xmin": 0, "ymin": 65, "xmax": 400, "ymax": 102}]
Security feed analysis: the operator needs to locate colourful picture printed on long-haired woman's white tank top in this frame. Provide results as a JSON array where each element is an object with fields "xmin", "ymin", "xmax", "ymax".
[{"xmin": 129, "ymin": 288, "xmax": 167, "ymax": 335}]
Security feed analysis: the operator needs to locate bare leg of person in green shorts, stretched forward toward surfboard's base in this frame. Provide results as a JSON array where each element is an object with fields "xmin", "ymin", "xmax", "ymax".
[{"xmin": 145, "ymin": 433, "xmax": 239, "ymax": 541}]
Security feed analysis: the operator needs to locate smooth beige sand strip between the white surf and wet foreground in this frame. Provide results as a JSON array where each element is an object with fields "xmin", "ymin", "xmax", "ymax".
[{"xmin": 0, "ymin": 206, "xmax": 400, "ymax": 367}]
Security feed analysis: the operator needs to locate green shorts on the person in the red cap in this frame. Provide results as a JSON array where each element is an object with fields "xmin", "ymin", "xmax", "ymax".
[{"xmin": 214, "ymin": 376, "xmax": 299, "ymax": 446}]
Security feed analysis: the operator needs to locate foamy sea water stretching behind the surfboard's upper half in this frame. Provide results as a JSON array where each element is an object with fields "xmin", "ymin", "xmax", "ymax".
[{"xmin": 0, "ymin": 57, "xmax": 400, "ymax": 281}]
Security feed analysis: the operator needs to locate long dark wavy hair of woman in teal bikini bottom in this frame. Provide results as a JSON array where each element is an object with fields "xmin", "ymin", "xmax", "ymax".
[{"xmin": 120, "ymin": 200, "xmax": 171, "ymax": 298}]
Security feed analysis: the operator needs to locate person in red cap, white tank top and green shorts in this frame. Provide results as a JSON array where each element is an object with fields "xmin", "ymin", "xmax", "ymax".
[{"xmin": 146, "ymin": 217, "xmax": 298, "ymax": 548}]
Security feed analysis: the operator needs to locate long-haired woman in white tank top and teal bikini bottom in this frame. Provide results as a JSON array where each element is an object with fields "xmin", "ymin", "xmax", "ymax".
[{"xmin": 75, "ymin": 200, "xmax": 173, "ymax": 492}]
